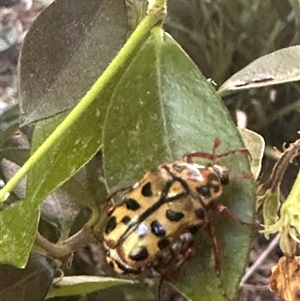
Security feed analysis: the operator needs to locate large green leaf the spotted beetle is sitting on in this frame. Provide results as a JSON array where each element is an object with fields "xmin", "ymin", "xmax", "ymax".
[{"xmin": 103, "ymin": 28, "xmax": 255, "ymax": 301}]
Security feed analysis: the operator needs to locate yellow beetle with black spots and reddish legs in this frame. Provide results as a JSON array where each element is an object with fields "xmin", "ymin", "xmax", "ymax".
[{"xmin": 104, "ymin": 139, "xmax": 249, "ymax": 274}]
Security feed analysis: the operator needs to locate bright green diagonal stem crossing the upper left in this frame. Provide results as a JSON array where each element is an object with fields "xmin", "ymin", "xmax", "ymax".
[{"xmin": 0, "ymin": 0, "xmax": 166, "ymax": 203}]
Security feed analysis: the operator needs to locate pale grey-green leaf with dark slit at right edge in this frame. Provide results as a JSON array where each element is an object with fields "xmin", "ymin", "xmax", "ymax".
[{"xmin": 218, "ymin": 45, "xmax": 300, "ymax": 94}]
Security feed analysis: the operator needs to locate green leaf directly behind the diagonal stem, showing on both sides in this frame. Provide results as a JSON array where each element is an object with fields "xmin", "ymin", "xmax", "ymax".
[{"xmin": 27, "ymin": 106, "xmax": 100, "ymax": 204}]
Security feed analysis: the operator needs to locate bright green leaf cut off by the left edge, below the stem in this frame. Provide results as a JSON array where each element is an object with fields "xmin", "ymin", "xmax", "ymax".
[{"xmin": 0, "ymin": 201, "xmax": 39, "ymax": 268}]
